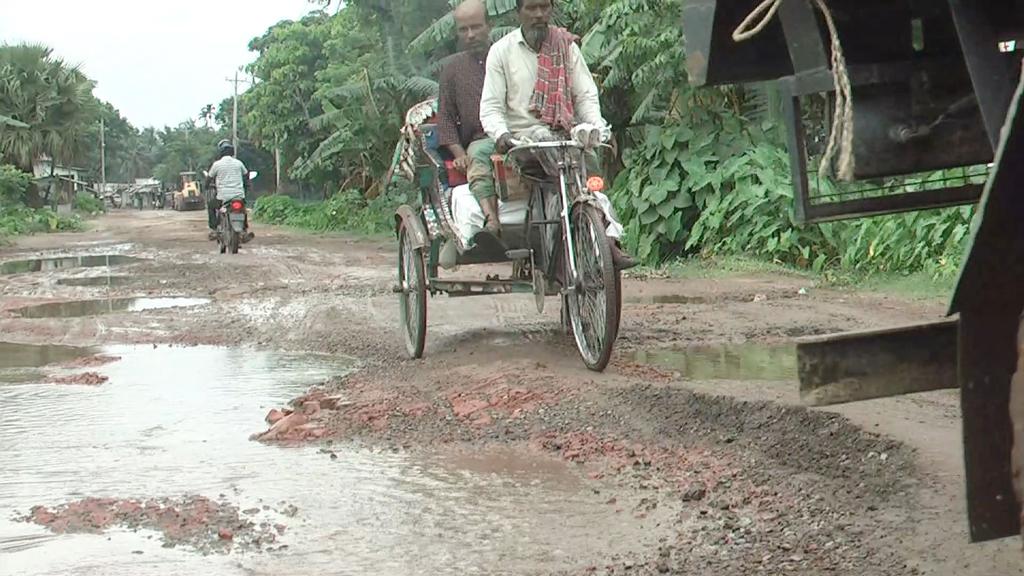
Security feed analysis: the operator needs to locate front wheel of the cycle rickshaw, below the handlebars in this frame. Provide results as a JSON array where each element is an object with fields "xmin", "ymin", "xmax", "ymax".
[{"xmin": 565, "ymin": 205, "xmax": 621, "ymax": 372}]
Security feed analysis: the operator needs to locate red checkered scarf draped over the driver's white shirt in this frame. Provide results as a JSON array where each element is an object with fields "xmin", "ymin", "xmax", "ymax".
[{"xmin": 529, "ymin": 27, "xmax": 580, "ymax": 132}]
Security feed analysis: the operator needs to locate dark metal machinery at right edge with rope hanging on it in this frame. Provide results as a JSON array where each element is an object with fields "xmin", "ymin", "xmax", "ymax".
[{"xmin": 683, "ymin": 0, "xmax": 1024, "ymax": 541}]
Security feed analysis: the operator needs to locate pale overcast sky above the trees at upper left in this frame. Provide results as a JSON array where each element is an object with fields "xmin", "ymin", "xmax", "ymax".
[{"xmin": 0, "ymin": 0, "xmax": 314, "ymax": 127}]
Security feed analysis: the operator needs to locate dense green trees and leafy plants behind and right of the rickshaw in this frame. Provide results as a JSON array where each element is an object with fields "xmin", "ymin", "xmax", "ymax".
[{"xmin": 251, "ymin": 0, "xmax": 973, "ymax": 282}]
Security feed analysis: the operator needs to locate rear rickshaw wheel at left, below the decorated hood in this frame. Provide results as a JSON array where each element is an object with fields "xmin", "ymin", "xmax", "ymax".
[{"xmin": 398, "ymin": 224, "xmax": 427, "ymax": 358}]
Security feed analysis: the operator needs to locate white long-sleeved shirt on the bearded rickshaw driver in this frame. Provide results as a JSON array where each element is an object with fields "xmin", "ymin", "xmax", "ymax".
[{"xmin": 480, "ymin": 29, "xmax": 607, "ymax": 140}]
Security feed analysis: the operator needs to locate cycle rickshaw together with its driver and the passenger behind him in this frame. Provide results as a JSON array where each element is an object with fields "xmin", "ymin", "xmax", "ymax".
[{"xmin": 392, "ymin": 0, "xmax": 635, "ymax": 370}]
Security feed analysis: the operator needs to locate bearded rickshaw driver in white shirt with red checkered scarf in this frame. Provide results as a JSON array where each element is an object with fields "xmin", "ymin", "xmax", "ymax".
[{"xmin": 471, "ymin": 0, "xmax": 636, "ymax": 270}]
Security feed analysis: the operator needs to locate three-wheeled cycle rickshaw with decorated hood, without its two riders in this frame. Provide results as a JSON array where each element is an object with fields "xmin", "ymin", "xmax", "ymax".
[{"xmin": 386, "ymin": 99, "xmax": 622, "ymax": 371}]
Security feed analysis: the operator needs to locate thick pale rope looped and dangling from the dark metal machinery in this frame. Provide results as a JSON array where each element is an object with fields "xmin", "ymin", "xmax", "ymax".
[{"xmin": 732, "ymin": 0, "xmax": 855, "ymax": 180}]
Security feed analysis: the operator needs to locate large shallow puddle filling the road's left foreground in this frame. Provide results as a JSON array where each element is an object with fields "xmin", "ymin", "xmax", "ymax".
[{"xmin": 0, "ymin": 346, "xmax": 670, "ymax": 576}]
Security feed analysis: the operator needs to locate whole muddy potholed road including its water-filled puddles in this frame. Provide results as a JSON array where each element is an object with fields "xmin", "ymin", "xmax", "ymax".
[{"xmin": 0, "ymin": 211, "xmax": 1024, "ymax": 576}]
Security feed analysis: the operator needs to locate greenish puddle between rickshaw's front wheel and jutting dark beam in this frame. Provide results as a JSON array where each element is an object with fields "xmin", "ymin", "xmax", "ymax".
[{"xmin": 633, "ymin": 343, "xmax": 797, "ymax": 381}]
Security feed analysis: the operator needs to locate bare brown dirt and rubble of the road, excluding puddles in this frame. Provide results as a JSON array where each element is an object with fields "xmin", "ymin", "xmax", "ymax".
[{"xmin": 0, "ymin": 211, "xmax": 1024, "ymax": 575}]
